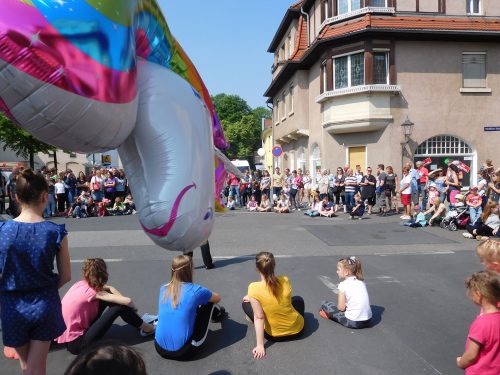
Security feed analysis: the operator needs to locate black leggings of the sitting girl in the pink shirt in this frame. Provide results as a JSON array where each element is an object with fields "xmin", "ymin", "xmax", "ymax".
[{"xmin": 66, "ymin": 301, "xmax": 142, "ymax": 354}]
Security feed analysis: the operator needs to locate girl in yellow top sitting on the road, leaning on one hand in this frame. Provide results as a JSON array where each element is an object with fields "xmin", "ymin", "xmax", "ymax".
[{"xmin": 242, "ymin": 251, "xmax": 304, "ymax": 359}]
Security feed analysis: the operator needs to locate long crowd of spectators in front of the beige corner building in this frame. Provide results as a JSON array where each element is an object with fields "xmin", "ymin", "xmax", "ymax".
[{"xmin": 224, "ymin": 160, "xmax": 500, "ymax": 237}]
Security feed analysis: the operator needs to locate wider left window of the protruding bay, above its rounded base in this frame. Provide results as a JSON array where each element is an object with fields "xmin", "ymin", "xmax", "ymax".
[{"xmin": 333, "ymin": 52, "xmax": 365, "ymax": 90}]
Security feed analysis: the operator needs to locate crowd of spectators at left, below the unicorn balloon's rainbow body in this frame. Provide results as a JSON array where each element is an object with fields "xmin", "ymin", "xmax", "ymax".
[{"xmin": 0, "ymin": 168, "xmax": 136, "ymax": 218}]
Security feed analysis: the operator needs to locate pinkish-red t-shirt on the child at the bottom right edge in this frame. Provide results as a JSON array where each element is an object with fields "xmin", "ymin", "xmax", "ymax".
[{"xmin": 465, "ymin": 311, "xmax": 500, "ymax": 375}]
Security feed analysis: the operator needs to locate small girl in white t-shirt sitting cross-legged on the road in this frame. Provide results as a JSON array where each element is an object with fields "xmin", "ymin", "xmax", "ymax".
[{"xmin": 319, "ymin": 256, "xmax": 372, "ymax": 329}]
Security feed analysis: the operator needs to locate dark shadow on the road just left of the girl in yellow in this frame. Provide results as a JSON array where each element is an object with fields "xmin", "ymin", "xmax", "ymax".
[{"xmin": 186, "ymin": 318, "xmax": 248, "ymax": 362}]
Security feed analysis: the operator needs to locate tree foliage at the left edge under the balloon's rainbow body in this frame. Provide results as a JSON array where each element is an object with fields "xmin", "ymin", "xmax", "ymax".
[{"xmin": 0, "ymin": 112, "xmax": 56, "ymax": 169}]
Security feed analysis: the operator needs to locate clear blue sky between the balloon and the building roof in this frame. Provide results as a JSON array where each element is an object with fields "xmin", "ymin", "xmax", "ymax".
[{"xmin": 158, "ymin": 0, "xmax": 296, "ymax": 108}]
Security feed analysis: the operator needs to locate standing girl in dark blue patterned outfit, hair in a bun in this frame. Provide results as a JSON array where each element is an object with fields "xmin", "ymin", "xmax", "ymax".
[{"xmin": 0, "ymin": 169, "xmax": 71, "ymax": 374}]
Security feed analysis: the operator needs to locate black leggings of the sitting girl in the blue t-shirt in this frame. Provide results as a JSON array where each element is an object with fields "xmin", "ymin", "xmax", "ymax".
[{"xmin": 155, "ymin": 303, "xmax": 215, "ymax": 360}]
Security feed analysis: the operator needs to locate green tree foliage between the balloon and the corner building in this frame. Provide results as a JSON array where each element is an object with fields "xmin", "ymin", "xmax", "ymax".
[{"xmin": 212, "ymin": 94, "xmax": 271, "ymax": 159}]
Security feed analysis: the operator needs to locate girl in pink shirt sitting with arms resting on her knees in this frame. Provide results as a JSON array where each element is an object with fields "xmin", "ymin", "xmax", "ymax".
[{"xmin": 56, "ymin": 258, "xmax": 156, "ymax": 354}]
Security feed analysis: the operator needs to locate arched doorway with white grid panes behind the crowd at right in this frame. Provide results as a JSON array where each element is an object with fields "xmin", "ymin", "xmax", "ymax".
[{"xmin": 414, "ymin": 135, "xmax": 477, "ymax": 187}]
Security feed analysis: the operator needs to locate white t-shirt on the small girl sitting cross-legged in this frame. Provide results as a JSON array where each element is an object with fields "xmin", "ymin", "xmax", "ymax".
[{"xmin": 338, "ymin": 276, "xmax": 372, "ymax": 322}]
